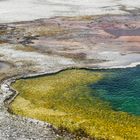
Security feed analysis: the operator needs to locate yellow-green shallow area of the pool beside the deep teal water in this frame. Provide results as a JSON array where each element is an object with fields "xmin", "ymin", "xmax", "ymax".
[{"xmin": 11, "ymin": 70, "xmax": 140, "ymax": 140}]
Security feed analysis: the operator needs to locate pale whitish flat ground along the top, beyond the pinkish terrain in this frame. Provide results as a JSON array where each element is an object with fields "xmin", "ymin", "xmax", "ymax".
[{"xmin": 0, "ymin": 0, "xmax": 140, "ymax": 23}]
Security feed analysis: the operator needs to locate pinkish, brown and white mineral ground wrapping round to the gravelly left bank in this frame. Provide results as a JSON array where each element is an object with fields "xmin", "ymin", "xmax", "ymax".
[{"xmin": 0, "ymin": 15, "xmax": 140, "ymax": 140}]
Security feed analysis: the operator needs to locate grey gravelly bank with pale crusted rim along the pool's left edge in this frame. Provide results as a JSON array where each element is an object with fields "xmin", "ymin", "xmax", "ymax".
[{"xmin": 0, "ymin": 71, "xmax": 79, "ymax": 140}]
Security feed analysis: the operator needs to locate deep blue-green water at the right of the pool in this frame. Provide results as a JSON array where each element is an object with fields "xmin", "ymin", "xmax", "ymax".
[{"xmin": 91, "ymin": 66, "xmax": 140, "ymax": 115}]
